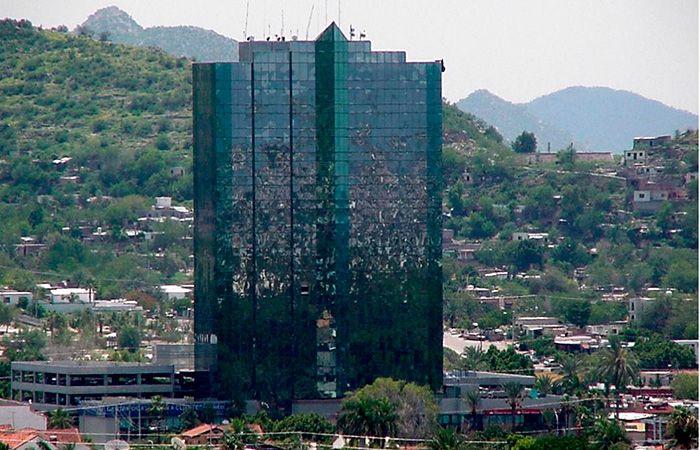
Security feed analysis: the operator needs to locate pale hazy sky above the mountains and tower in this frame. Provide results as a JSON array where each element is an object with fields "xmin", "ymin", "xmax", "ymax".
[{"xmin": 0, "ymin": 0, "xmax": 698, "ymax": 113}]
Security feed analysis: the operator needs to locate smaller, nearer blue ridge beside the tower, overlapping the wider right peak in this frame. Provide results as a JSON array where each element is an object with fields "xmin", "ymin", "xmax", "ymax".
[{"xmin": 457, "ymin": 89, "xmax": 574, "ymax": 151}]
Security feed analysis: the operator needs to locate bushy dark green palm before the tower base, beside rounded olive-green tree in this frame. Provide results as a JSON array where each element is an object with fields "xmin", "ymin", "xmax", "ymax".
[{"xmin": 338, "ymin": 396, "xmax": 398, "ymax": 436}]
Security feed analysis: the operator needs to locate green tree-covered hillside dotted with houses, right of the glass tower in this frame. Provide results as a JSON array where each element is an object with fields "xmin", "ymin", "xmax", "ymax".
[{"xmin": 443, "ymin": 97, "xmax": 698, "ymax": 339}]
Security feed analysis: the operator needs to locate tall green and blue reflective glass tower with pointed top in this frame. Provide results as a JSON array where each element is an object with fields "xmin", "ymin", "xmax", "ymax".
[{"xmin": 193, "ymin": 25, "xmax": 442, "ymax": 407}]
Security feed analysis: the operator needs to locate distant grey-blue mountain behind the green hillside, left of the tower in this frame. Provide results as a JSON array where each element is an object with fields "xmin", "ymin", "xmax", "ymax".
[{"xmin": 78, "ymin": 6, "xmax": 238, "ymax": 62}]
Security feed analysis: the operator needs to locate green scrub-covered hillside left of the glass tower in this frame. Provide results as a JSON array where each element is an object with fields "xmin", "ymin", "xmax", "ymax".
[{"xmin": 0, "ymin": 19, "xmax": 192, "ymax": 297}]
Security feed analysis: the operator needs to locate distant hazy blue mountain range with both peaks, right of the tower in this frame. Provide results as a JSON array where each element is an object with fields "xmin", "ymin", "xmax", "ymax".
[{"xmin": 457, "ymin": 86, "xmax": 698, "ymax": 153}]
